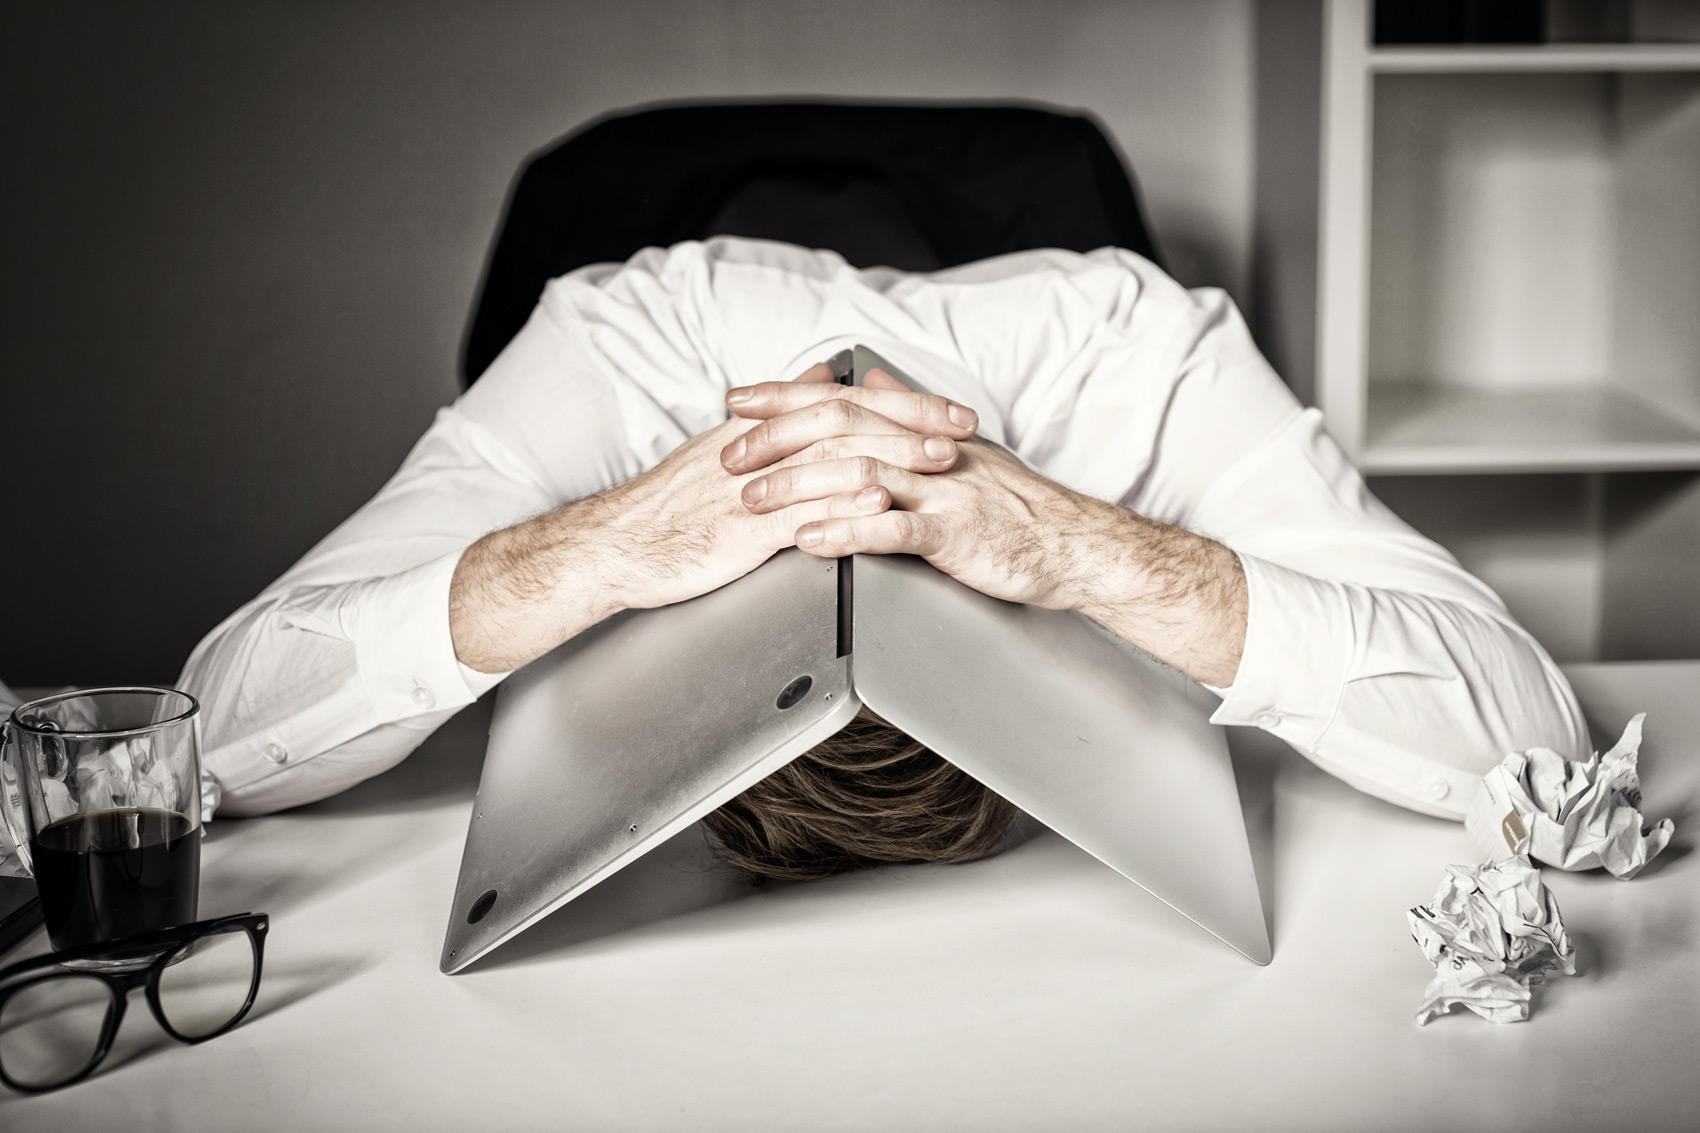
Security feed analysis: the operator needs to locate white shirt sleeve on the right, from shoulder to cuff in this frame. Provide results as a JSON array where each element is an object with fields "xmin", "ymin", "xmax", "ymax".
[{"xmin": 1120, "ymin": 273, "xmax": 1588, "ymax": 818}]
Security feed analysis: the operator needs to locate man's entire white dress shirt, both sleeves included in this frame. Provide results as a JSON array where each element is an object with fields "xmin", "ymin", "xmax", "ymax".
[{"xmin": 180, "ymin": 238, "xmax": 1588, "ymax": 818}]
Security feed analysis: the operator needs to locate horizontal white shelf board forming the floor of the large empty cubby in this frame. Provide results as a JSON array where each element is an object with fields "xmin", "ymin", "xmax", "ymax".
[{"xmin": 1362, "ymin": 383, "xmax": 1700, "ymax": 475}]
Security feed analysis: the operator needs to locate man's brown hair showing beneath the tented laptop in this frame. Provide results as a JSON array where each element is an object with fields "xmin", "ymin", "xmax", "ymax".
[{"xmin": 704, "ymin": 708, "xmax": 1015, "ymax": 885}]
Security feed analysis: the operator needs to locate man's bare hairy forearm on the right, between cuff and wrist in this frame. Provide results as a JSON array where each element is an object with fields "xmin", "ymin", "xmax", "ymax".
[{"xmin": 1069, "ymin": 500, "xmax": 1248, "ymax": 686}]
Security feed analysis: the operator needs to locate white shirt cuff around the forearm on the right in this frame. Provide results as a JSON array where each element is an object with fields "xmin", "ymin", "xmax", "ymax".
[{"xmin": 1210, "ymin": 555, "xmax": 1353, "ymax": 749}]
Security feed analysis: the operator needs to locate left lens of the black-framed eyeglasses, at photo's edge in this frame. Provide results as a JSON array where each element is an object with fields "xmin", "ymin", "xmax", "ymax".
[{"xmin": 0, "ymin": 975, "xmax": 112, "ymax": 1087}]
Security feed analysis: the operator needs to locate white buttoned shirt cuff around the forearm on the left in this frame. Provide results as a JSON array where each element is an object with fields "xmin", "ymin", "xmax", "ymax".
[{"xmin": 347, "ymin": 551, "xmax": 507, "ymax": 723}]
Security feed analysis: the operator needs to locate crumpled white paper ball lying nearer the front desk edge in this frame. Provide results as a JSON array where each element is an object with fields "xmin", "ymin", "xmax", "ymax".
[{"xmin": 1406, "ymin": 856, "xmax": 1576, "ymax": 1026}]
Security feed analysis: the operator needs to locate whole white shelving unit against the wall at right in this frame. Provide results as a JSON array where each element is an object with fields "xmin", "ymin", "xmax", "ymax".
[{"xmin": 1314, "ymin": 0, "xmax": 1700, "ymax": 660}]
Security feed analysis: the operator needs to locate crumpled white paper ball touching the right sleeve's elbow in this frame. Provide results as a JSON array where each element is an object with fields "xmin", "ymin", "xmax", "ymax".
[{"xmin": 1464, "ymin": 713, "xmax": 1676, "ymax": 881}]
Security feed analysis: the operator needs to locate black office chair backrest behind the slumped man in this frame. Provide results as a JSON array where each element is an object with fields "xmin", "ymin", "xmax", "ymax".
[{"xmin": 462, "ymin": 102, "xmax": 1161, "ymax": 384}]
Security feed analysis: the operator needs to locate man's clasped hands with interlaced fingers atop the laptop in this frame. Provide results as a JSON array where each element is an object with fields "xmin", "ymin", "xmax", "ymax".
[{"xmin": 602, "ymin": 358, "xmax": 1120, "ymax": 619}]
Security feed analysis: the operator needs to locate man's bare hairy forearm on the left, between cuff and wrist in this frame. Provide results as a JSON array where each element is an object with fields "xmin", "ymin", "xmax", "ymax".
[{"xmin": 449, "ymin": 498, "xmax": 621, "ymax": 672}]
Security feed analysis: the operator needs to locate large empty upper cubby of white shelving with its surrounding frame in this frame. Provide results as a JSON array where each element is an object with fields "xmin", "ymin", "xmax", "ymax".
[{"xmin": 1318, "ymin": 0, "xmax": 1700, "ymax": 475}]
